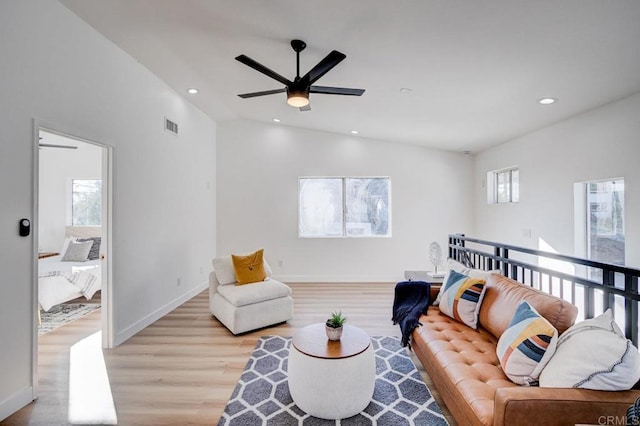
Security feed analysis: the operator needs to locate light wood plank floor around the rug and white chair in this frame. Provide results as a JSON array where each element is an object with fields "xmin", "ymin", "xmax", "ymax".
[{"xmin": 3, "ymin": 283, "xmax": 456, "ymax": 426}]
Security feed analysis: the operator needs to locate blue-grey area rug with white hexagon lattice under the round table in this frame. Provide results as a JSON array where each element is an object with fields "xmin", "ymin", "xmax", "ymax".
[{"xmin": 218, "ymin": 336, "xmax": 448, "ymax": 426}]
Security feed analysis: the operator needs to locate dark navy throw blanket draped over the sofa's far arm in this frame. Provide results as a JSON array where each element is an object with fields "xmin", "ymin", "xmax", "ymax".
[{"xmin": 391, "ymin": 281, "xmax": 431, "ymax": 349}]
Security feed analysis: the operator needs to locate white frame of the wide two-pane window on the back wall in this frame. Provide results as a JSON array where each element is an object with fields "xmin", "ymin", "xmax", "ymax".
[{"xmin": 297, "ymin": 176, "xmax": 392, "ymax": 239}]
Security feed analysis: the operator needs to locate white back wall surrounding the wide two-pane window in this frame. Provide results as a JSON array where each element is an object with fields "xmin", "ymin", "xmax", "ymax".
[{"xmin": 216, "ymin": 120, "xmax": 473, "ymax": 282}]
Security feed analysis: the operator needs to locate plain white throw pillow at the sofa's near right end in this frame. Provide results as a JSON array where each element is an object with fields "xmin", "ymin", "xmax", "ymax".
[{"xmin": 540, "ymin": 309, "xmax": 640, "ymax": 391}]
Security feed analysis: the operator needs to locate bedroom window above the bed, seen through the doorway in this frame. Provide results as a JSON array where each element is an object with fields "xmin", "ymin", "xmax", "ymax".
[{"xmin": 71, "ymin": 179, "xmax": 102, "ymax": 226}]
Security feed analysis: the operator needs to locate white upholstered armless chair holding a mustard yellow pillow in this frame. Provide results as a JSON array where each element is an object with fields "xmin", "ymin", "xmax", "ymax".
[{"xmin": 209, "ymin": 256, "xmax": 293, "ymax": 334}]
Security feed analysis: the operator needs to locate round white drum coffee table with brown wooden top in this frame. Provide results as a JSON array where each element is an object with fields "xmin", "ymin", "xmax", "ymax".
[{"xmin": 288, "ymin": 324, "xmax": 376, "ymax": 420}]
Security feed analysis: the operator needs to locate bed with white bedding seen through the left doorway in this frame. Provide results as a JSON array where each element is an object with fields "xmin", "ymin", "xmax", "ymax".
[{"xmin": 38, "ymin": 227, "xmax": 102, "ymax": 312}]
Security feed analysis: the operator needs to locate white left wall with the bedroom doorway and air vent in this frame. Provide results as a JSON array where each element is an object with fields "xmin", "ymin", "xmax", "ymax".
[{"xmin": 0, "ymin": 0, "xmax": 216, "ymax": 419}]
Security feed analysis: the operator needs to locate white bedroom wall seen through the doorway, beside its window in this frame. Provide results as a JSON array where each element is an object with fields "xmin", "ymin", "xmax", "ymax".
[{"xmin": 38, "ymin": 133, "xmax": 102, "ymax": 253}]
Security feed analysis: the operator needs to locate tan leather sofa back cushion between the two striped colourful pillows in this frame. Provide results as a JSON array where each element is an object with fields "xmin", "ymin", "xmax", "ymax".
[{"xmin": 479, "ymin": 274, "xmax": 578, "ymax": 338}]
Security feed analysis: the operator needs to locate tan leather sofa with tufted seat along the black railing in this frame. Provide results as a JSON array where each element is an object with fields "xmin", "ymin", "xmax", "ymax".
[{"xmin": 412, "ymin": 274, "xmax": 640, "ymax": 426}]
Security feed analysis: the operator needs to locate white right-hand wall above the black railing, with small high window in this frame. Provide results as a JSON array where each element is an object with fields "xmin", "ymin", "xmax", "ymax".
[{"xmin": 474, "ymin": 94, "xmax": 640, "ymax": 267}]
